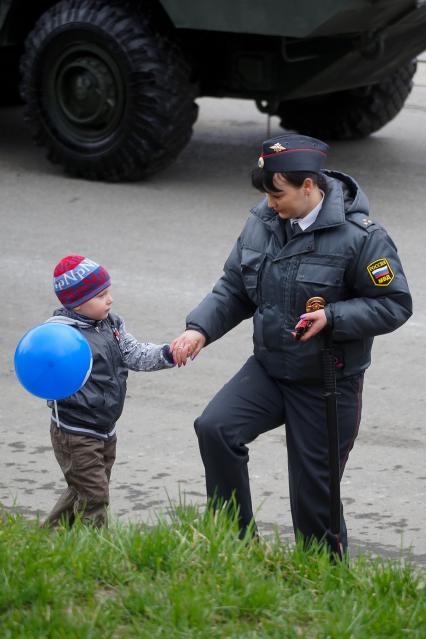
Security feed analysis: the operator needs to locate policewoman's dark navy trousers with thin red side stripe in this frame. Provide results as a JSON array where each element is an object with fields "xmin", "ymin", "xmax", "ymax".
[{"xmin": 195, "ymin": 357, "xmax": 363, "ymax": 548}]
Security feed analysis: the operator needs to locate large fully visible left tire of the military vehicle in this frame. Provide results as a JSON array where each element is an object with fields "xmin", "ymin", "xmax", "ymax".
[{"xmin": 21, "ymin": 0, "xmax": 197, "ymax": 181}]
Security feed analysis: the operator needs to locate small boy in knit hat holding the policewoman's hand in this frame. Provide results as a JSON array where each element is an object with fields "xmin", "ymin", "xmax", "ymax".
[{"xmin": 44, "ymin": 255, "xmax": 174, "ymax": 527}]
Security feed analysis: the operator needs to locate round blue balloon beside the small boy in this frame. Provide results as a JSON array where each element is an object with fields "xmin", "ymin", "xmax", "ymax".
[{"xmin": 15, "ymin": 322, "xmax": 92, "ymax": 399}]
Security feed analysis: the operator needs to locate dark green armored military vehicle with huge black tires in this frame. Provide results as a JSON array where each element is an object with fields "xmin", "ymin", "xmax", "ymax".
[{"xmin": 0, "ymin": 0, "xmax": 426, "ymax": 181}]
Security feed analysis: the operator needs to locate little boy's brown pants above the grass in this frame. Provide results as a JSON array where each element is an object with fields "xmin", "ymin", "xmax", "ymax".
[{"xmin": 43, "ymin": 422, "xmax": 117, "ymax": 527}]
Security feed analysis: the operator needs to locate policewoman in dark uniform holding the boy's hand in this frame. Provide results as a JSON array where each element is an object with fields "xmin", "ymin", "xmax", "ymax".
[{"xmin": 172, "ymin": 134, "xmax": 412, "ymax": 549}]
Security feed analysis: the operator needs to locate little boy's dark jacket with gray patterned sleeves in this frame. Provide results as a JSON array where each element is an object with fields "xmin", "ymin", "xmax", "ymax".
[{"xmin": 48, "ymin": 308, "xmax": 174, "ymax": 439}]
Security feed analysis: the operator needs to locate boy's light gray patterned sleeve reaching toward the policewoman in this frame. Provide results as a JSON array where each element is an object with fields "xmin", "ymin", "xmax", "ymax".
[{"xmin": 118, "ymin": 318, "xmax": 175, "ymax": 371}]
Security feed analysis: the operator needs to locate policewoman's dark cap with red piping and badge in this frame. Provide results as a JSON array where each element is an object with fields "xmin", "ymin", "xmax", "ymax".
[{"xmin": 258, "ymin": 133, "xmax": 328, "ymax": 173}]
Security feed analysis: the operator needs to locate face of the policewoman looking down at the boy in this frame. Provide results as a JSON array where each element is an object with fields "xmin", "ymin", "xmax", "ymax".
[{"xmin": 266, "ymin": 173, "xmax": 313, "ymax": 220}]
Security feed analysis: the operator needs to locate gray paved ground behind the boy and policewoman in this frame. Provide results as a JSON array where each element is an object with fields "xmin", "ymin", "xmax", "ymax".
[{"xmin": 0, "ymin": 56, "xmax": 426, "ymax": 563}]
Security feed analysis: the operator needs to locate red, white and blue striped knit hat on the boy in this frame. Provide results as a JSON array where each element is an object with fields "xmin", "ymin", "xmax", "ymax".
[{"xmin": 53, "ymin": 255, "xmax": 111, "ymax": 308}]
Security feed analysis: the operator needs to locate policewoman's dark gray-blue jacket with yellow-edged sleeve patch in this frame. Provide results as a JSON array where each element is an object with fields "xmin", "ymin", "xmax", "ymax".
[{"xmin": 187, "ymin": 171, "xmax": 412, "ymax": 381}]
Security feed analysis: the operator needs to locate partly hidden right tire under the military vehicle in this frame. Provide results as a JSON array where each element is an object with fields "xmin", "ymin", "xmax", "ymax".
[{"xmin": 277, "ymin": 61, "xmax": 416, "ymax": 140}]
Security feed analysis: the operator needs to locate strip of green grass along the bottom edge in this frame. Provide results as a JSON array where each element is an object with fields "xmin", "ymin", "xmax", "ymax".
[{"xmin": 0, "ymin": 506, "xmax": 426, "ymax": 639}]
